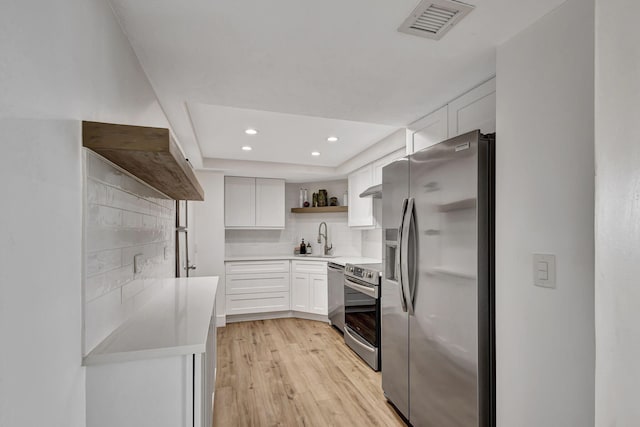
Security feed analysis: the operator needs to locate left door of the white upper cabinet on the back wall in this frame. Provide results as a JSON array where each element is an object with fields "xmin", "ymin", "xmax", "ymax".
[{"xmin": 224, "ymin": 176, "xmax": 256, "ymax": 227}]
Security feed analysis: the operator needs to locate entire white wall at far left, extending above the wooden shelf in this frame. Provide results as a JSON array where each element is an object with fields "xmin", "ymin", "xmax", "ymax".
[{"xmin": 0, "ymin": 0, "xmax": 172, "ymax": 427}]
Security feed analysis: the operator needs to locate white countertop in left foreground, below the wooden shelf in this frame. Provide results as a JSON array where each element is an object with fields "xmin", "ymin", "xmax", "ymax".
[{"xmin": 83, "ymin": 277, "xmax": 218, "ymax": 366}]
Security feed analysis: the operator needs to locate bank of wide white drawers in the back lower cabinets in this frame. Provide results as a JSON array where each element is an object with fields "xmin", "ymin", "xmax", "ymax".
[{"xmin": 225, "ymin": 261, "xmax": 290, "ymax": 315}]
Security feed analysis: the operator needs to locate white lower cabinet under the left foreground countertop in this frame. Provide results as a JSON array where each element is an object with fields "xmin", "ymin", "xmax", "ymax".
[{"xmin": 86, "ymin": 304, "xmax": 216, "ymax": 427}]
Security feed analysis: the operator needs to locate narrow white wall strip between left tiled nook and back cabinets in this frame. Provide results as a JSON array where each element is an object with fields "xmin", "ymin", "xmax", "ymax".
[{"xmin": 189, "ymin": 171, "xmax": 226, "ymax": 326}]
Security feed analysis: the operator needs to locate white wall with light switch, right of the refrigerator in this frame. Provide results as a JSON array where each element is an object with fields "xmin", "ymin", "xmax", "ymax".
[{"xmin": 496, "ymin": 0, "xmax": 596, "ymax": 427}]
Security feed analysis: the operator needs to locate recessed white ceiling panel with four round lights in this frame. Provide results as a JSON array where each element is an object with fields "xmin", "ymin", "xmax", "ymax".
[{"xmin": 188, "ymin": 103, "xmax": 397, "ymax": 167}]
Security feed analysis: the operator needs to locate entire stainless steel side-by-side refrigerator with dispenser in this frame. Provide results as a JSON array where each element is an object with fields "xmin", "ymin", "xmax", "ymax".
[{"xmin": 381, "ymin": 131, "xmax": 495, "ymax": 427}]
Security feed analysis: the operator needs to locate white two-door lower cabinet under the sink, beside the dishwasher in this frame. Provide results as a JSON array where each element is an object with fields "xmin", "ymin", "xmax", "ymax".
[{"xmin": 291, "ymin": 261, "xmax": 329, "ymax": 316}]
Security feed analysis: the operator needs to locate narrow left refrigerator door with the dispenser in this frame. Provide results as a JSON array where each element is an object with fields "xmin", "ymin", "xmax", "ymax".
[{"xmin": 380, "ymin": 159, "xmax": 409, "ymax": 417}]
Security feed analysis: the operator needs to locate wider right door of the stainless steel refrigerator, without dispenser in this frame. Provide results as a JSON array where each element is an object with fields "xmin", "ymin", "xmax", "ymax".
[{"xmin": 409, "ymin": 133, "xmax": 479, "ymax": 427}]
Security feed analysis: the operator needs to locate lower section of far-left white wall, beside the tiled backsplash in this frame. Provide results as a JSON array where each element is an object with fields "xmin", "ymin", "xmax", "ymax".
[{"xmin": 0, "ymin": 120, "xmax": 84, "ymax": 427}]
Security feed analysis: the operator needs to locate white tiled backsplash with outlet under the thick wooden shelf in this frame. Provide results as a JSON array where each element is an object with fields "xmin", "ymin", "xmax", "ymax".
[{"xmin": 83, "ymin": 150, "xmax": 175, "ymax": 354}]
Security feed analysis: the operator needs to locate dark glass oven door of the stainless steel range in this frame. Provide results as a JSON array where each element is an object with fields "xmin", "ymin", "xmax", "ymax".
[{"xmin": 344, "ymin": 276, "xmax": 380, "ymax": 348}]
